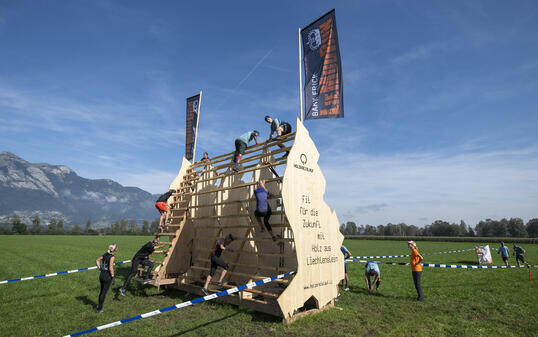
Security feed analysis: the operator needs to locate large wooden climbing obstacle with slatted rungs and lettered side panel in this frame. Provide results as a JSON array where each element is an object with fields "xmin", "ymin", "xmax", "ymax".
[{"xmin": 151, "ymin": 119, "xmax": 344, "ymax": 322}]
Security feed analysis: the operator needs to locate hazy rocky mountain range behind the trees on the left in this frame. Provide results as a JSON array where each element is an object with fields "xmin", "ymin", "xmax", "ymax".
[{"xmin": 0, "ymin": 152, "xmax": 159, "ymax": 227}]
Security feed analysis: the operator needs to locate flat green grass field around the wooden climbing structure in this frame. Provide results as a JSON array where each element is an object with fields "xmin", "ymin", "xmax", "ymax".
[{"xmin": 0, "ymin": 236, "xmax": 538, "ymax": 336}]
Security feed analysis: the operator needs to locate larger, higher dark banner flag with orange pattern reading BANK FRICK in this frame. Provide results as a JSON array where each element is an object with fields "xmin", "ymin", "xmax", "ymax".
[{"xmin": 301, "ymin": 9, "xmax": 344, "ymax": 120}]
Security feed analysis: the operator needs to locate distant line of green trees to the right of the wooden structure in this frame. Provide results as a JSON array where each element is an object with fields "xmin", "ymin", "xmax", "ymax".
[{"xmin": 340, "ymin": 218, "xmax": 538, "ymax": 238}]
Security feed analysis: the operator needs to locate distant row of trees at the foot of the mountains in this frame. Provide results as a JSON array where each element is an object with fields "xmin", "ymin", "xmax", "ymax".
[{"xmin": 0, "ymin": 215, "xmax": 159, "ymax": 235}]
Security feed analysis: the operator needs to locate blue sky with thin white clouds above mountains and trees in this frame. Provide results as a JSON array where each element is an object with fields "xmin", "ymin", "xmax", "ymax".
[{"xmin": 0, "ymin": 0, "xmax": 538, "ymax": 225}]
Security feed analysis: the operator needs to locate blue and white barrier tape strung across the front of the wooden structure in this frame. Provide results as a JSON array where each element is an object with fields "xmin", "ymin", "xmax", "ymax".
[{"xmin": 64, "ymin": 271, "xmax": 295, "ymax": 337}]
